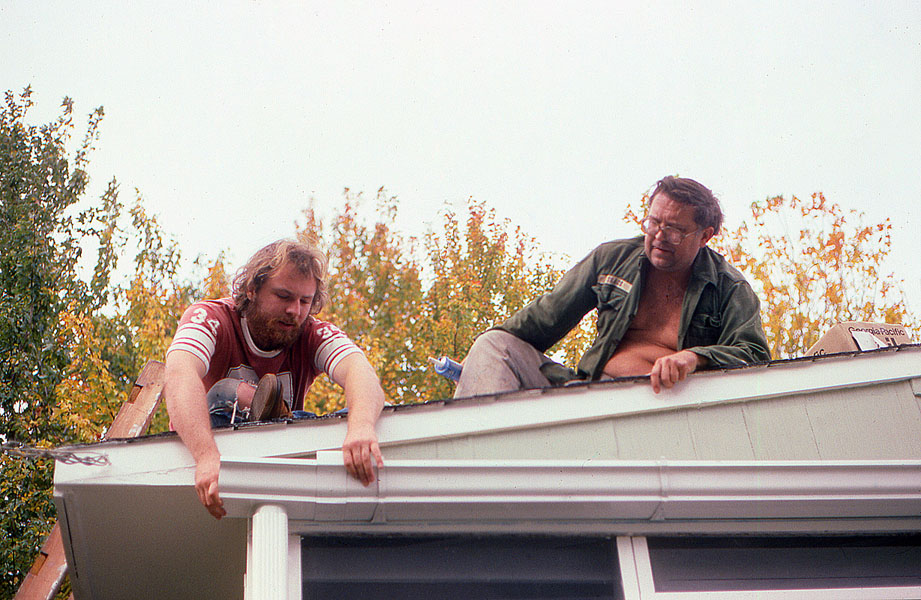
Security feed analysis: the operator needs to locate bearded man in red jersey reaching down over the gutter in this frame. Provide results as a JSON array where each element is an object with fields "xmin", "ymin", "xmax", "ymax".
[{"xmin": 163, "ymin": 240, "xmax": 384, "ymax": 519}]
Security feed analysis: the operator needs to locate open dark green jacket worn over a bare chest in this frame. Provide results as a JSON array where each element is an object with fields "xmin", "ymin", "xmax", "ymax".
[{"xmin": 498, "ymin": 236, "xmax": 771, "ymax": 380}]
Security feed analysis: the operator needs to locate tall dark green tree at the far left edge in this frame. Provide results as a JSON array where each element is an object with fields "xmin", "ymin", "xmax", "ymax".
[{"xmin": 0, "ymin": 88, "xmax": 116, "ymax": 597}]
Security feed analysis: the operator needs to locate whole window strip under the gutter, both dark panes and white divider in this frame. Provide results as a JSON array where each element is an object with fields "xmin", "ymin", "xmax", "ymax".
[{"xmin": 299, "ymin": 534, "xmax": 921, "ymax": 600}]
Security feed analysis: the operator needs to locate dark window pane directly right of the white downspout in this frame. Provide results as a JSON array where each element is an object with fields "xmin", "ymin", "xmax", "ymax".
[{"xmin": 301, "ymin": 535, "xmax": 623, "ymax": 600}]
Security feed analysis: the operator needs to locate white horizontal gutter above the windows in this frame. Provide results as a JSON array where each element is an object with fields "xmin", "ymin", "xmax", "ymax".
[{"xmin": 221, "ymin": 452, "xmax": 921, "ymax": 533}]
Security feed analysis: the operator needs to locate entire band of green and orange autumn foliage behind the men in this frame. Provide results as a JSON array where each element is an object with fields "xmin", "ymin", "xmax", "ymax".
[{"xmin": 0, "ymin": 89, "xmax": 919, "ymax": 596}]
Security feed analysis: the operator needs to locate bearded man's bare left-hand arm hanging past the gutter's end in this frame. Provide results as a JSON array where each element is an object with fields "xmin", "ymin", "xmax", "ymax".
[{"xmin": 163, "ymin": 350, "xmax": 227, "ymax": 519}]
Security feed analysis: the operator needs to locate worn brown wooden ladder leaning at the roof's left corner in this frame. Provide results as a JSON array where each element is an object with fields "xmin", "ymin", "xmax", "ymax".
[{"xmin": 14, "ymin": 360, "xmax": 163, "ymax": 600}]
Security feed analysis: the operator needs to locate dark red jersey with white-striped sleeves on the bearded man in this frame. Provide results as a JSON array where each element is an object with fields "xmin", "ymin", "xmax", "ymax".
[{"xmin": 166, "ymin": 298, "xmax": 361, "ymax": 410}]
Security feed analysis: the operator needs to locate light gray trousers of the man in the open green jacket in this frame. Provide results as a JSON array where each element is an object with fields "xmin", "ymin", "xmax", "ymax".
[{"xmin": 454, "ymin": 329, "xmax": 553, "ymax": 398}]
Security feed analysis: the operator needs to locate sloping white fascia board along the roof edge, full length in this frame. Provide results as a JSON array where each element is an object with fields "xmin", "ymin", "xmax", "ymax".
[{"xmin": 48, "ymin": 346, "xmax": 921, "ymax": 484}]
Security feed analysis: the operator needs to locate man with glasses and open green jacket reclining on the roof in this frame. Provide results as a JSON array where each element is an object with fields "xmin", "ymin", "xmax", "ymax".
[{"xmin": 455, "ymin": 177, "xmax": 770, "ymax": 397}]
